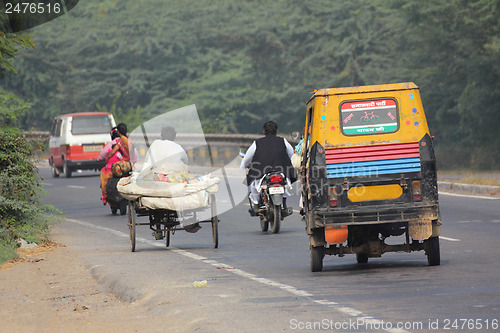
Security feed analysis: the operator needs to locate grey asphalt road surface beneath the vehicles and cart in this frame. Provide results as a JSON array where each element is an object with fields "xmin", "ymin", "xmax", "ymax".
[{"xmin": 40, "ymin": 168, "xmax": 500, "ymax": 332}]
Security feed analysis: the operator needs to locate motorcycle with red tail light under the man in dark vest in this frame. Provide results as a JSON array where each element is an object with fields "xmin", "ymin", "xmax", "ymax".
[{"xmin": 249, "ymin": 172, "xmax": 293, "ymax": 233}]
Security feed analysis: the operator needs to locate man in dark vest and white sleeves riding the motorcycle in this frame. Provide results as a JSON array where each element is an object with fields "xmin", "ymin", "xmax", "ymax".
[{"xmin": 240, "ymin": 121, "xmax": 297, "ymax": 215}]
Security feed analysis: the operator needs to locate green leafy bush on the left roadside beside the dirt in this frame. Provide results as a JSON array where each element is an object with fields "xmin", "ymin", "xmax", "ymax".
[{"xmin": 0, "ymin": 94, "xmax": 57, "ymax": 263}]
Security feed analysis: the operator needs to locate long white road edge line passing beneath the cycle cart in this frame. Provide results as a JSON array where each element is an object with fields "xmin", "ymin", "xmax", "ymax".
[{"xmin": 66, "ymin": 219, "xmax": 410, "ymax": 333}]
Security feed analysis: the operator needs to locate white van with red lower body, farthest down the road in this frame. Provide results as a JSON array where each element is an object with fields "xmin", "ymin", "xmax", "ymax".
[{"xmin": 49, "ymin": 112, "xmax": 116, "ymax": 178}]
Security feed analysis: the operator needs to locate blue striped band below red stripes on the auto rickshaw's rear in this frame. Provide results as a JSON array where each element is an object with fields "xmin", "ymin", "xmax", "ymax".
[{"xmin": 326, "ymin": 157, "xmax": 420, "ymax": 178}]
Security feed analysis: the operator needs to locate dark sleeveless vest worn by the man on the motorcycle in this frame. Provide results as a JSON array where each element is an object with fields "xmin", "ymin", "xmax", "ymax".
[{"xmin": 247, "ymin": 135, "xmax": 297, "ymax": 185}]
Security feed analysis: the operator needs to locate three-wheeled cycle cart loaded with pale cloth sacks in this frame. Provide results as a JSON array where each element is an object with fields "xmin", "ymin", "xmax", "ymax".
[{"xmin": 119, "ymin": 172, "xmax": 219, "ymax": 252}]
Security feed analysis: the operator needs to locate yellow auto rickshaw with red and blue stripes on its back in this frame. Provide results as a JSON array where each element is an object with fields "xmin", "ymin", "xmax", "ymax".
[{"xmin": 300, "ymin": 82, "xmax": 441, "ymax": 272}]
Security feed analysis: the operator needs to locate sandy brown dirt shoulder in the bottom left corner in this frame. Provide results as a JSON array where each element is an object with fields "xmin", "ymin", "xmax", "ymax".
[{"xmin": 0, "ymin": 243, "xmax": 185, "ymax": 333}]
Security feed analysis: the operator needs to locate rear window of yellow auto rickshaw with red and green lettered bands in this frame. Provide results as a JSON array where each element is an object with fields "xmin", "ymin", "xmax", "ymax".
[{"xmin": 340, "ymin": 98, "xmax": 398, "ymax": 135}]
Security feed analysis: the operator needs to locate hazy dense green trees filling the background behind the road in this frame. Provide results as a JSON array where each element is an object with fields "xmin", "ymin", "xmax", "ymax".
[{"xmin": 0, "ymin": 0, "xmax": 500, "ymax": 168}]
